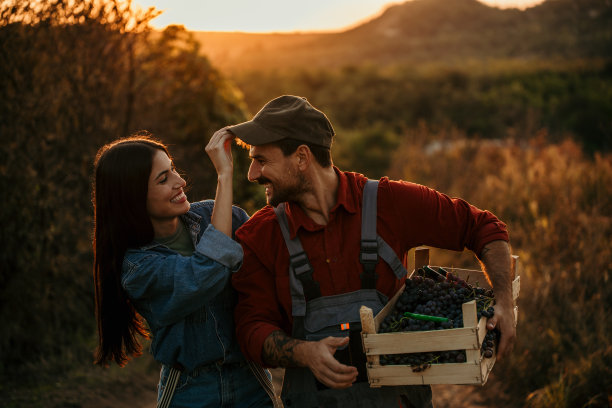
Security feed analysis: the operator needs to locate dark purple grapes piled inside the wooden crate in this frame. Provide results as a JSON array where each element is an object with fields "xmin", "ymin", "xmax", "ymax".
[{"xmin": 379, "ymin": 266, "xmax": 498, "ymax": 372}]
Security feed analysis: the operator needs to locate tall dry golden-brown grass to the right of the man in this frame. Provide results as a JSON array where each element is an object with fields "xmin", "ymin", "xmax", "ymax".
[{"xmin": 390, "ymin": 127, "xmax": 612, "ymax": 408}]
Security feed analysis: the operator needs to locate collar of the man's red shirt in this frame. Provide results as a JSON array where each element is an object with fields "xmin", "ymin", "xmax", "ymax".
[{"xmin": 285, "ymin": 166, "xmax": 360, "ymax": 238}]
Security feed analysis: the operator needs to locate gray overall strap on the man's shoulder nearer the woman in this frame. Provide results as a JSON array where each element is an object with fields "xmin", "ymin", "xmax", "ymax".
[{"xmin": 274, "ymin": 203, "xmax": 321, "ymax": 316}]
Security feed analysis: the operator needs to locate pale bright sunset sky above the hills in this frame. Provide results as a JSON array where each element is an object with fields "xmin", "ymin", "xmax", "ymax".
[{"xmin": 132, "ymin": 0, "xmax": 543, "ymax": 33}]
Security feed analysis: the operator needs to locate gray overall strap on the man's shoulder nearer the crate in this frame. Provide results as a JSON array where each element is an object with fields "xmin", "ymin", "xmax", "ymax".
[{"xmin": 359, "ymin": 180, "xmax": 378, "ymax": 289}]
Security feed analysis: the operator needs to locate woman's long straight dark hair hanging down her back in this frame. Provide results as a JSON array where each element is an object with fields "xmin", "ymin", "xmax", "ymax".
[{"xmin": 92, "ymin": 133, "xmax": 170, "ymax": 366}]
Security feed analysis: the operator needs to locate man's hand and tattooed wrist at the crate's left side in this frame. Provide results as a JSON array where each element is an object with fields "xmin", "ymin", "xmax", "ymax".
[{"xmin": 263, "ymin": 331, "xmax": 358, "ymax": 388}]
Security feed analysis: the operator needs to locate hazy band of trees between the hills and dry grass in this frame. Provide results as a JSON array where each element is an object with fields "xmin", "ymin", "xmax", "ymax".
[{"xmin": 234, "ymin": 60, "xmax": 612, "ymax": 171}]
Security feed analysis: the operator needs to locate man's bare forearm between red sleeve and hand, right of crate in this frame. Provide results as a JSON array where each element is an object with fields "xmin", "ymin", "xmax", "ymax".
[{"xmin": 479, "ymin": 240, "xmax": 513, "ymax": 303}]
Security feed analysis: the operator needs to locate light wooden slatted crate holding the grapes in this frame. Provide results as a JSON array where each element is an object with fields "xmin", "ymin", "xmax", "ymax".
[{"xmin": 361, "ymin": 248, "xmax": 520, "ymax": 387}]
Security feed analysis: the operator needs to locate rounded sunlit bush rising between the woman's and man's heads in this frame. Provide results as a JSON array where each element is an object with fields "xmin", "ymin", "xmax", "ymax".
[{"xmin": 130, "ymin": 26, "xmax": 256, "ymax": 212}]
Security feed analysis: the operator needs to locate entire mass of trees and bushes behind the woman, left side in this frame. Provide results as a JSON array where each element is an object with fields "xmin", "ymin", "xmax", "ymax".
[{"xmin": 0, "ymin": 0, "xmax": 251, "ymax": 378}]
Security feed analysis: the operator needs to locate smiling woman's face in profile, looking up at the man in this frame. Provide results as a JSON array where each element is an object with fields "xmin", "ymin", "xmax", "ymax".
[{"xmin": 147, "ymin": 150, "xmax": 189, "ymax": 228}]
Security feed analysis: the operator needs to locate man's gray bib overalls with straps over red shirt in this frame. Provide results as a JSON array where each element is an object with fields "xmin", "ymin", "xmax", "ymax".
[{"xmin": 274, "ymin": 180, "xmax": 432, "ymax": 408}]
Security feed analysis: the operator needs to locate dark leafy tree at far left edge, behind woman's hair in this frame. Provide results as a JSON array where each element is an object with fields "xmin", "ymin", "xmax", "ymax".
[{"xmin": 0, "ymin": 2, "xmax": 153, "ymax": 378}]
